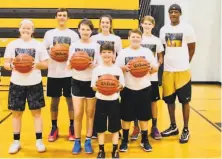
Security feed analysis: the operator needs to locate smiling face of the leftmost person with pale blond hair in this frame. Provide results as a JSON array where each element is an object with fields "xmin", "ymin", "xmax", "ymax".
[{"xmin": 19, "ymin": 22, "xmax": 34, "ymax": 40}]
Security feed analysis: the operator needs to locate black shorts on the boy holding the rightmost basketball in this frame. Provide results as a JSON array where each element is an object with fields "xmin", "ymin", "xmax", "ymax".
[{"xmin": 120, "ymin": 86, "xmax": 152, "ymax": 121}]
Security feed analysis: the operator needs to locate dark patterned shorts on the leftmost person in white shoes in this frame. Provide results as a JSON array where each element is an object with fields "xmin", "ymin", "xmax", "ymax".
[{"xmin": 8, "ymin": 82, "xmax": 45, "ymax": 111}]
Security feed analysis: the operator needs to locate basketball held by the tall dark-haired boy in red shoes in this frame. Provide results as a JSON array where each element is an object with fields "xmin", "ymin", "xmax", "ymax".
[{"xmin": 50, "ymin": 44, "xmax": 69, "ymax": 62}]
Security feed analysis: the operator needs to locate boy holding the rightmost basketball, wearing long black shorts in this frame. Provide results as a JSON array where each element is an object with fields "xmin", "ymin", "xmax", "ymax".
[{"xmin": 116, "ymin": 29, "xmax": 157, "ymax": 152}]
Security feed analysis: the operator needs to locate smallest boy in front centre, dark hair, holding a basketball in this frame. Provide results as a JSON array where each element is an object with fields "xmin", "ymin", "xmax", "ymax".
[{"xmin": 91, "ymin": 42, "xmax": 125, "ymax": 158}]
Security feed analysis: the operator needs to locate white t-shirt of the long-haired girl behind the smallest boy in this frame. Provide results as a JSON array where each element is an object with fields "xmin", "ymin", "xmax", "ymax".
[{"xmin": 91, "ymin": 33, "xmax": 122, "ymax": 54}]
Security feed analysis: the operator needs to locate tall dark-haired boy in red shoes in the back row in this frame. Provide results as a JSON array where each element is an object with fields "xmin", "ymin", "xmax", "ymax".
[{"xmin": 43, "ymin": 8, "xmax": 79, "ymax": 142}]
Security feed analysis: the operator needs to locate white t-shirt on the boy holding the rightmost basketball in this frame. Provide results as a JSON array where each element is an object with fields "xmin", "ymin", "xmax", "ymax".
[{"xmin": 116, "ymin": 47, "xmax": 157, "ymax": 90}]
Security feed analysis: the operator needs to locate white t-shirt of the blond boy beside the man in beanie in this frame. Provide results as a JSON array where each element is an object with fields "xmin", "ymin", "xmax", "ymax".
[{"xmin": 141, "ymin": 35, "xmax": 164, "ymax": 81}]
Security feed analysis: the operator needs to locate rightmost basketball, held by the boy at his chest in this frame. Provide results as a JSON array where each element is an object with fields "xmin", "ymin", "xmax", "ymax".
[{"xmin": 130, "ymin": 57, "xmax": 149, "ymax": 78}]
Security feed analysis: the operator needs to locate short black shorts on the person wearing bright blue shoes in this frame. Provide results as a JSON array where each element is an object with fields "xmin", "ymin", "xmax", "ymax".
[{"xmin": 72, "ymin": 78, "xmax": 95, "ymax": 98}]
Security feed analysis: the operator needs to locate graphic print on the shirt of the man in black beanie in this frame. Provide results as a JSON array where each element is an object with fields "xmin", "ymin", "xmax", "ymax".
[{"xmin": 165, "ymin": 33, "xmax": 183, "ymax": 47}]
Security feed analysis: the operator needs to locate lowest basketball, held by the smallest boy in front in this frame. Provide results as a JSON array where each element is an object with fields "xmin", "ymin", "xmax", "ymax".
[{"xmin": 96, "ymin": 74, "xmax": 119, "ymax": 95}]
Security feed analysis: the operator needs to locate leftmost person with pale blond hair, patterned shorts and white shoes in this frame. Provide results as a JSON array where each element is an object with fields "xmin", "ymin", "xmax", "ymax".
[{"xmin": 4, "ymin": 19, "xmax": 49, "ymax": 154}]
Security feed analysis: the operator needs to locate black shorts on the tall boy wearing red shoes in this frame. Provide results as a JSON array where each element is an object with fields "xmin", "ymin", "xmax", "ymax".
[{"xmin": 47, "ymin": 77, "xmax": 72, "ymax": 98}]
